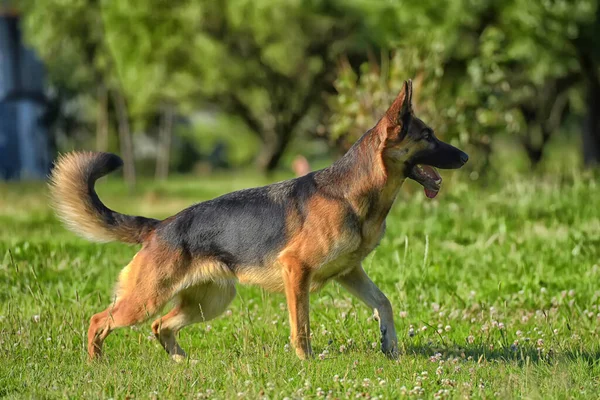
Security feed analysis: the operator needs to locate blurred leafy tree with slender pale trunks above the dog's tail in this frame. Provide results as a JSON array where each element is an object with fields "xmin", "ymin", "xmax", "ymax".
[{"xmin": 20, "ymin": 0, "xmax": 135, "ymax": 186}]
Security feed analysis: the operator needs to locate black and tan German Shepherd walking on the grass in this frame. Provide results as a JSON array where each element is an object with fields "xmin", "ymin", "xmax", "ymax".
[{"xmin": 50, "ymin": 81, "xmax": 468, "ymax": 361}]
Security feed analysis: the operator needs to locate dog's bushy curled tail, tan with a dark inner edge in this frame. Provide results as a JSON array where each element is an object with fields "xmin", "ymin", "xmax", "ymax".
[{"xmin": 50, "ymin": 152, "xmax": 159, "ymax": 243}]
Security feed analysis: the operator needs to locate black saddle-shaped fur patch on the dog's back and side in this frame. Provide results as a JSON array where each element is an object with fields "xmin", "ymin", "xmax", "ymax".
[{"xmin": 155, "ymin": 184, "xmax": 288, "ymax": 270}]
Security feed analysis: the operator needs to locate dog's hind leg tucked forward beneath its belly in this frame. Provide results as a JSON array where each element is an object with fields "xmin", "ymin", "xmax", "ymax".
[{"xmin": 152, "ymin": 282, "xmax": 236, "ymax": 361}]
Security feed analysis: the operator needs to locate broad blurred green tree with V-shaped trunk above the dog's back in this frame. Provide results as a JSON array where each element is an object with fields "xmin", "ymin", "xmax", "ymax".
[{"xmin": 99, "ymin": 0, "xmax": 360, "ymax": 170}]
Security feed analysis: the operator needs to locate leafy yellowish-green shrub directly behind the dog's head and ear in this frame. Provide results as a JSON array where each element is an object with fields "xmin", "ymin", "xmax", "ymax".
[{"xmin": 328, "ymin": 49, "xmax": 471, "ymax": 148}]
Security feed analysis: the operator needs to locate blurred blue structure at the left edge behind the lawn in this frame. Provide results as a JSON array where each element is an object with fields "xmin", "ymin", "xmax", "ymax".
[{"xmin": 0, "ymin": 5, "xmax": 51, "ymax": 179}]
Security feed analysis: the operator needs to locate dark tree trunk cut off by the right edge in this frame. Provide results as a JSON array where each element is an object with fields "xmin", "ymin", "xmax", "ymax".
[{"xmin": 582, "ymin": 77, "xmax": 600, "ymax": 167}]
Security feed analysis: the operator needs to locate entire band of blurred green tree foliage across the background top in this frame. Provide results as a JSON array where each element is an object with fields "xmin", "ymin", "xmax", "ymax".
[{"xmin": 16, "ymin": 0, "xmax": 600, "ymax": 169}]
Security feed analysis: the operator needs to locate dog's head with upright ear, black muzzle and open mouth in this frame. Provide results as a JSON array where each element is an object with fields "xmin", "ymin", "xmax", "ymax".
[{"xmin": 380, "ymin": 80, "xmax": 469, "ymax": 198}]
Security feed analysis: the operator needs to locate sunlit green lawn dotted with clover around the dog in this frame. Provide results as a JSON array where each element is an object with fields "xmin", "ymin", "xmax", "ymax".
[{"xmin": 0, "ymin": 173, "xmax": 600, "ymax": 399}]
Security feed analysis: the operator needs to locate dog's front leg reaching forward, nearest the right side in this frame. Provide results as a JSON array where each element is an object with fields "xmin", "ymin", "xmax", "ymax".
[{"xmin": 337, "ymin": 265, "xmax": 398, "ymax": 358}]
